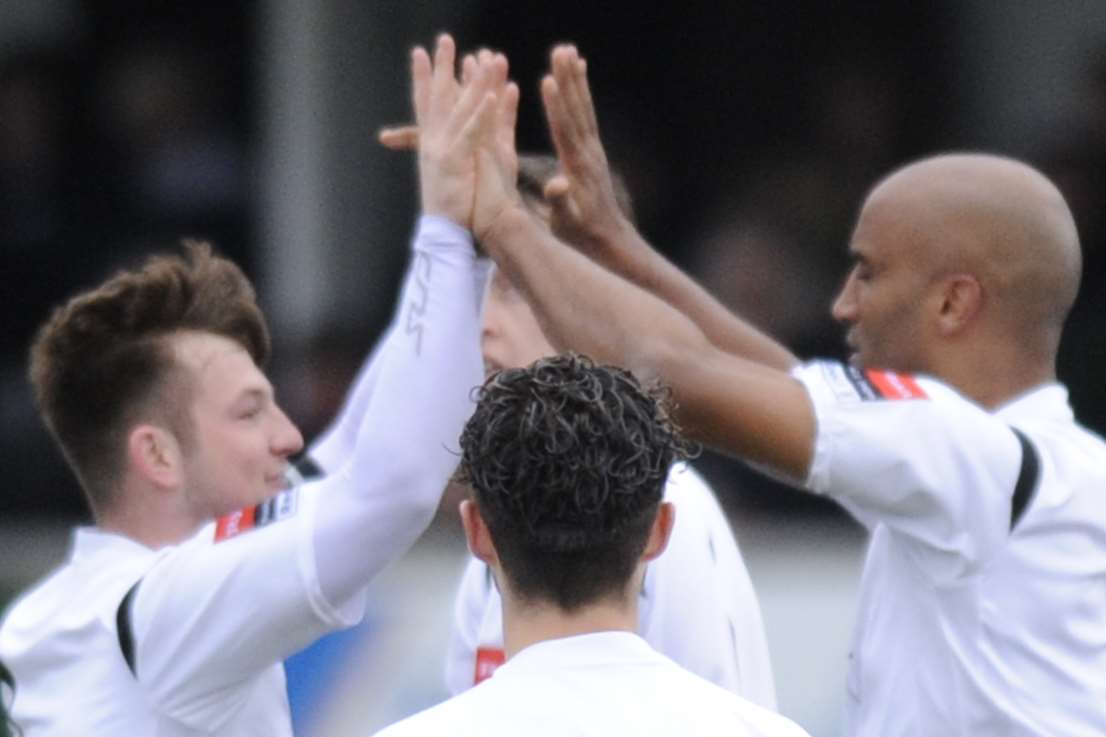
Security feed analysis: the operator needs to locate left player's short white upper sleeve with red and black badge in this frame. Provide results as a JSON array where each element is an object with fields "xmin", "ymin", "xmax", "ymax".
[{"xmin": 126, "ymin": 487, "xmax": 336, "ymax": 730}]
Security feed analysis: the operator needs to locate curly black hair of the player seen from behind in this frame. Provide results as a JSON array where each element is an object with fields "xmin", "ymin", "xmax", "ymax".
[{"xmin": 460, "ymin": 353, "xmax": 693, "ymax": 611}]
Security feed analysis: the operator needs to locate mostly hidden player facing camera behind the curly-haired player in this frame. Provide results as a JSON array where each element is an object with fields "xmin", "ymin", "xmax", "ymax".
[{"xmin": 431, "ymin": 154, "xmax": 776, "ymax": 709}]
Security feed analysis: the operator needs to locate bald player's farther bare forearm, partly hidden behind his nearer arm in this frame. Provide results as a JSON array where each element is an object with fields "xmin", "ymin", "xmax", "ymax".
[{"xmin": 588, "ymin": 216, "xmax": 797, "ymax": 371}]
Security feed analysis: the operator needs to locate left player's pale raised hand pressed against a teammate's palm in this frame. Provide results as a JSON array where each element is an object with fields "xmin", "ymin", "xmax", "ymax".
[{"xmin": 411, "ymin": 34, "xmax": 507, "ymax": 229}]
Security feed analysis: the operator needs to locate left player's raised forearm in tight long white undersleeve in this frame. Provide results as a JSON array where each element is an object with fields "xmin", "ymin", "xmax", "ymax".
[{"xmin": 315, "ymin": 219, "xmax": 482, "ymax": 602}]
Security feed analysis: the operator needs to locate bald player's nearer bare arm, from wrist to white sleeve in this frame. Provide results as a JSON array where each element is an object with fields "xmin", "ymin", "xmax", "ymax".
[{"xmin": 481, "ymin": 204, "xmax": 814, "ymax": 478}]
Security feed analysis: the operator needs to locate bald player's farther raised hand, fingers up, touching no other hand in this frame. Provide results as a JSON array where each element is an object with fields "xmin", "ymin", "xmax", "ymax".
[{"xmin": 542, "ymin": 45, "xmax": 632, "ymax": 250}]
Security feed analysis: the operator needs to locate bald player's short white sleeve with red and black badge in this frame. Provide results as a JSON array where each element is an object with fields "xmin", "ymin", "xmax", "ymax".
[{"xmin": 794, "ymin": 362, "xmax": 1023, "ymax": 583}]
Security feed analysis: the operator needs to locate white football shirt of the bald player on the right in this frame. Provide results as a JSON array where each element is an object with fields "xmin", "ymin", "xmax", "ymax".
[{"xmin": 796, "ymin": 362, "xmax": 1106, "ymax": 737}]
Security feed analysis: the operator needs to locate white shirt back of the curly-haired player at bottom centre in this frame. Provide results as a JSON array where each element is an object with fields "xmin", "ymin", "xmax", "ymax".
[{"xmin": 379, "ymin": 632, "xmax": 808, "ymax": 737}]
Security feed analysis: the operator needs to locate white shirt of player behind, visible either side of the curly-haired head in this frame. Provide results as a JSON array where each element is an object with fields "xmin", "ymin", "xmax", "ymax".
[{"xmin": 446, "ymin": 464, "xmax": 775, "ymax": 709}]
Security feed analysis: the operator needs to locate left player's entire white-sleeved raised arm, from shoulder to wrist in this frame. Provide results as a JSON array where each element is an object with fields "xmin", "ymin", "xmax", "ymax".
[{"xmin": 128, "ymin": 217, "xmax": 482, "ymax": 728}]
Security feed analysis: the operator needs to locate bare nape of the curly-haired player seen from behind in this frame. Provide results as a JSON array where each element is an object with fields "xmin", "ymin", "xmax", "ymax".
[{"xmin": 503, "ymin": 592, "xmax": 637, "ymax": 658}]
